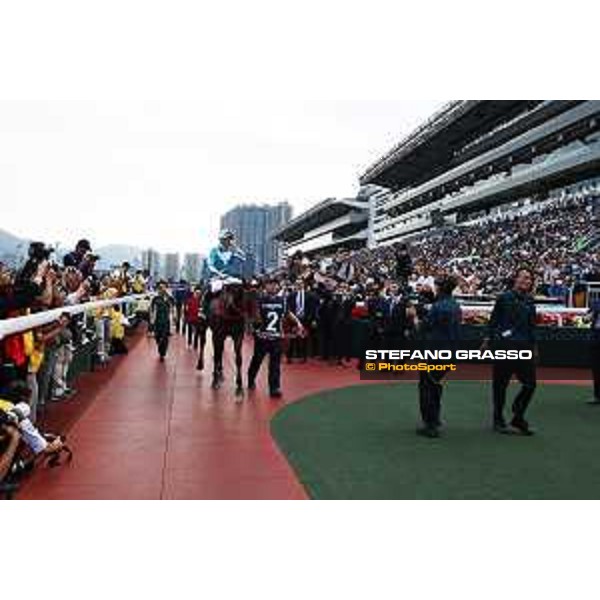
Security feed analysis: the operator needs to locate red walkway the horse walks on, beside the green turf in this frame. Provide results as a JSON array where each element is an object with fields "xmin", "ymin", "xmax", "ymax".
[{"xmin": 19, "ymin": 336, "xmax": 372, "ymax": 499}]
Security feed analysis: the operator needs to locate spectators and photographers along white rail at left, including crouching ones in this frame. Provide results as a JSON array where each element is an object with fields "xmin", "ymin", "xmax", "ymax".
[{"xmin": 0, "ymin": 240, "xmax": 155, "ymax": 493}]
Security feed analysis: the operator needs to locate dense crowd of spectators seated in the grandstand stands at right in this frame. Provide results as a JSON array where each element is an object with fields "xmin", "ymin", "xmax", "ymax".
[{"xmin": 280, "ymin": 194, "xmax": 600, "ymax": 302}]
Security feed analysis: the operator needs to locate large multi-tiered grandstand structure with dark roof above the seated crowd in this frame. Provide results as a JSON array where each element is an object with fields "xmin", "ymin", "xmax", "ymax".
[{"xmin": 360, "ymin": 100, "xmax": 600, "ymax": 245}]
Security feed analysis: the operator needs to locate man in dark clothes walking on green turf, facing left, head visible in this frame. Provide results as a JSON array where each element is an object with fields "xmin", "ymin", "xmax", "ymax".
[{"xmin": 483, "ymin": 268, "xmax": 536, "ymax": 435}]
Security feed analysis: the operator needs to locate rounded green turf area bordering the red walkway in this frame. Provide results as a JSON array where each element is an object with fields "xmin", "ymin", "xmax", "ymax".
[{"xmin": 271, "ymin": 382, "xmax": 600, "ymax": 499}]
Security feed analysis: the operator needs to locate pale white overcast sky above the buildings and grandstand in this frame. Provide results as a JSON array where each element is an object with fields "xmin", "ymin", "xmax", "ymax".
[{"xmin": 0, "ymin": 98, "xmax": 437, "ymax": 252}]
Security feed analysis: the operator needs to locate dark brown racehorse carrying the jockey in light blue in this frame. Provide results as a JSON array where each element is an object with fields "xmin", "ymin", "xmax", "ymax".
[{"xmin": 204, "ymin": 283, "xmax": 253, "ymax": 396}]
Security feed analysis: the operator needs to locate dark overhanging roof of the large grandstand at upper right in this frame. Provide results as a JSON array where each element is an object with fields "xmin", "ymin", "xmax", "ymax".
[{"xmin": 360, "ymin": 100, "xmax": 542, "ymax": 189}]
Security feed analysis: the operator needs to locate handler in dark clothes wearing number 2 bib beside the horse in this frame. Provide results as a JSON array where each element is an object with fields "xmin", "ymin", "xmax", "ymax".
[{"xmin": 248, "ymin": 278, "xmax": 304, "ymax": 398}]
